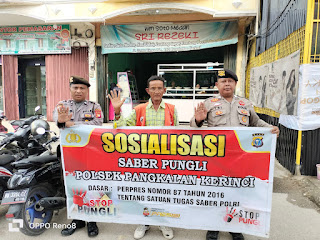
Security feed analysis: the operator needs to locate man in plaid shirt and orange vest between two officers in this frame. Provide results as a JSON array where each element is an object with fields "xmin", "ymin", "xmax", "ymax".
[{"xmin": 109, "ymin": 76, "xmax": 179, "ymax": 239}]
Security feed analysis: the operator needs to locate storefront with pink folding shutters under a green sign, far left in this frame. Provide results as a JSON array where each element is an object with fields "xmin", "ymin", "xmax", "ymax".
[{"xmin": 0, "ymin": 24, "xmax": 92, "ymax": 121}]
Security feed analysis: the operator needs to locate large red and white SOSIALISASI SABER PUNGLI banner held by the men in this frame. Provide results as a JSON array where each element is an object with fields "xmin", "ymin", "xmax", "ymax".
[{"xmin": 61, "ymin": 125, "xmax": 276, "ymax": 237}]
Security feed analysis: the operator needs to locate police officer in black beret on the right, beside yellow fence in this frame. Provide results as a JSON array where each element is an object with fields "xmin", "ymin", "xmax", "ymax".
[{"xmin": 190, "ymin": 69, "xmax": 279, "ymax": 240}]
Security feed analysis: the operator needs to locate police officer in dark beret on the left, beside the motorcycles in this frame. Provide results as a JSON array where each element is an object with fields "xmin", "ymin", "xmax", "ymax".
[{"xmin": 53, "ymin": 76, "xmax": 103, "ymax": 237}]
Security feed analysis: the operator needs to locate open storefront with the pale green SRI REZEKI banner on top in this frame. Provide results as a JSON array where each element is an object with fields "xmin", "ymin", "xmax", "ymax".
[{"xmin": 101, "ymin": 21, "xmax": 239, "ymax": 122}]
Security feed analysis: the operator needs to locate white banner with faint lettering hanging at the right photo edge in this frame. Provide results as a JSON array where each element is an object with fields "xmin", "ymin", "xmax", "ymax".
[{"xmin": 279, "ymin": 63, "xmax": 320, "ymax": 131}]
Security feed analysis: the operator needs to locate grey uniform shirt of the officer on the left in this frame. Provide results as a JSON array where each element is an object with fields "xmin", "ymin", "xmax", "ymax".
[{"xmin": 53, "ymin": 100, "xmax": 103, "ymax": 127}]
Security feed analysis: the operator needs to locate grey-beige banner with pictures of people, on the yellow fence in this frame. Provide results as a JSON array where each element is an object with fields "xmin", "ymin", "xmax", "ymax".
[{"xmin": 249, "ymin": 51, "xmax": 300, "ymax": 115}]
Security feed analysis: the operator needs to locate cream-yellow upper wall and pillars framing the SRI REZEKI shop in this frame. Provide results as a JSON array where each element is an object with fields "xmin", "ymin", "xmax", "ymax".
[{"xmin": 0, "ymin": 0, "xmax": 260, "ymax": 117}]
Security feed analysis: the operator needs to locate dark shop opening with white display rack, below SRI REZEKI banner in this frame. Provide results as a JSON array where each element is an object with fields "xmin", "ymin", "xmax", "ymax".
[{"xmin": 107, "ymin": 44, "xmax": 237, "ymax": 122}]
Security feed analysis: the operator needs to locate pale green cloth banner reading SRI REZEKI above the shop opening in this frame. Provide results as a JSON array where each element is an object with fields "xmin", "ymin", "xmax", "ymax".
[{"xmin": 100, "ymin": 21, "xmax": 238, "ymax": 54}]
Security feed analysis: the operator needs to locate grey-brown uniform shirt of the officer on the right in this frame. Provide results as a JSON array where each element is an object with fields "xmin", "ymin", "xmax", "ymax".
[{"xmin": 190, "ymin": 95, "xmax": 272, "ymax": 127}]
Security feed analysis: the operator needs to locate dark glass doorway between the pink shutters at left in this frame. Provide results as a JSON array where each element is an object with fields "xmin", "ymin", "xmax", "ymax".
[{"xmin": 18, "ymin": 56, "xmax": 47, "ymax": 118}]
